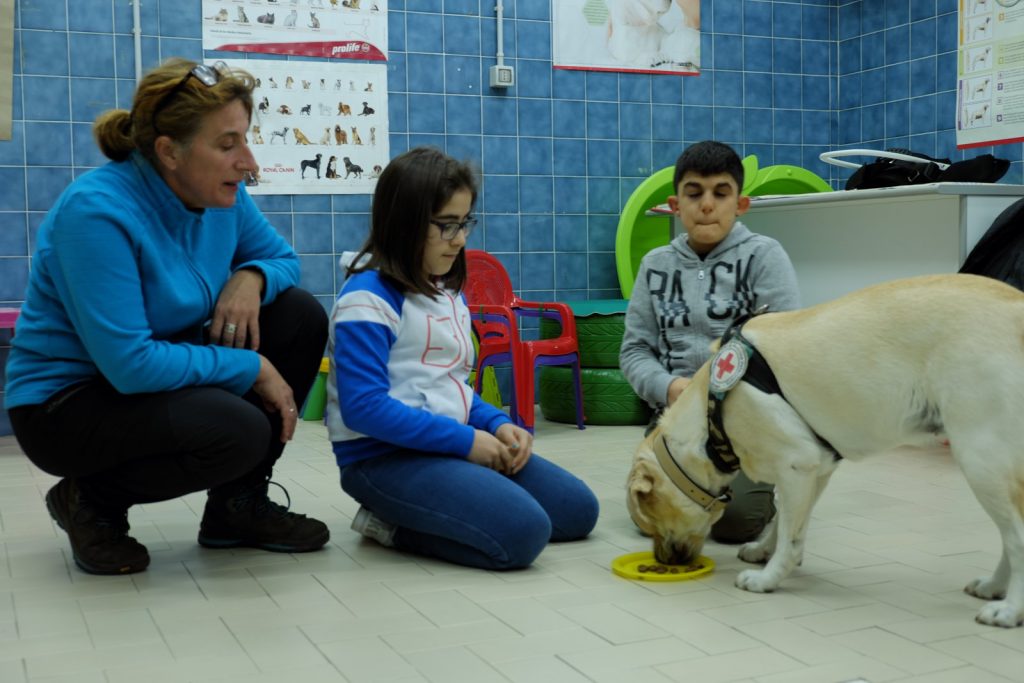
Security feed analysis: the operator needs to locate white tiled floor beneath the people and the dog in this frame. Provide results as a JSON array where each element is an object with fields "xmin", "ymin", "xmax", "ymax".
[{"xmin": 0, "ymin": 421, "xmax": 1024, "ymax": 683}]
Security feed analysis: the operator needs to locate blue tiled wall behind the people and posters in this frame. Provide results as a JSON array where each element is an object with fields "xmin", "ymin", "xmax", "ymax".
[{"xmin": 0, "ymin": 0, "xmax": 1007, "ymax": 313}]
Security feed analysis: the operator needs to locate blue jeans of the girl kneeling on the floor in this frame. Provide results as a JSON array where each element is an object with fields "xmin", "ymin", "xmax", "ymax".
[{"xmin": 341, "ymin": 451, "xmax": 598, "ymax": 569}]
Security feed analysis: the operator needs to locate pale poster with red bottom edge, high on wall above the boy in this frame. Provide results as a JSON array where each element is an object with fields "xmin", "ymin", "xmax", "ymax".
[{"xmin": 551, "ymin": 0, "xmax": 700, "ymax": 76}]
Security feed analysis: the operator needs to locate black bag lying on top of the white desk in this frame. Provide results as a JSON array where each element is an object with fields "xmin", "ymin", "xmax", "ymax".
[{"xmin": 846, "ymin": 150, "xmax": 1010, "ymax": 189}]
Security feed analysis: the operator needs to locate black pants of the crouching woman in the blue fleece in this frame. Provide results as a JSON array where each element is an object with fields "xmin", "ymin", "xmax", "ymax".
[{"xmin": 10, "ymin": 288, "xmax": 328, "ymax": 509}]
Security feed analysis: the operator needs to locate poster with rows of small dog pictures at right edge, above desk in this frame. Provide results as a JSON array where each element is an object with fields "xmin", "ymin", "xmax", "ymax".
[{"xmin": 956, "ymin": 0, "xmax": 1024, "ymax": 150}]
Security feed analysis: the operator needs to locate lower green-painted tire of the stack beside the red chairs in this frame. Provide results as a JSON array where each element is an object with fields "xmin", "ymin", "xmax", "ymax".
[{"xmin": 540, "ymin": 366, "xmax": 651, "ymax": 425}]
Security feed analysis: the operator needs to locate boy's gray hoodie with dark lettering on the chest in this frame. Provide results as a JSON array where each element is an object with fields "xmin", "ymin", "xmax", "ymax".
[{"xmin": 618, "ymin": 221, "xmax": 800, "ymax": 408}]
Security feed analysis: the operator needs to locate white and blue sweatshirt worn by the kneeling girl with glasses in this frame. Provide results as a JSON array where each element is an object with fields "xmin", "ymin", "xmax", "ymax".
[{"xmin": 325, "ymin": 270, "xmax": 511, "ymax": 467}]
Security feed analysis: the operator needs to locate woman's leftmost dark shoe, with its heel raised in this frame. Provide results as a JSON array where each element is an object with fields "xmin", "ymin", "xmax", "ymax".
[{"xmin": 46, "ymin": 479, "xmax": 150, "ymax": 574}]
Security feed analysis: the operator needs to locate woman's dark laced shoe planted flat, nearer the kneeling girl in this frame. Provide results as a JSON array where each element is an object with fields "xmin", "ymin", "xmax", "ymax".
[{"xmin": 199, "ymin": 479, "xmax": 331, "ymax": 553}]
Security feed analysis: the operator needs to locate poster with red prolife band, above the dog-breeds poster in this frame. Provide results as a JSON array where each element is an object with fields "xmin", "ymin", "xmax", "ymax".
[{"xmin": 203, "ymin": 0, "xmax": 387, "ymax": 61}]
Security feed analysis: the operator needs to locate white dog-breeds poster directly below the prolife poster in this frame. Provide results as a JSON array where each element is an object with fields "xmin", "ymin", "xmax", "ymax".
[{"xmin": 225, "ymin": 59, "xmax": 390, "ymax": 195}]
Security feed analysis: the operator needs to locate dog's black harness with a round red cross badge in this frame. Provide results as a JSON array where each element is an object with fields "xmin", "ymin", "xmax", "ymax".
[{"xmin": 705, "ymin": 305, "xmax": 841, "ymax": 474}]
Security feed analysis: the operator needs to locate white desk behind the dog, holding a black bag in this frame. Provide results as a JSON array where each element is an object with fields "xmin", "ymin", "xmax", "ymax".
[{"xmin": 740, "ymin": 182, "xmax": 1024, "ymax": 305}]
